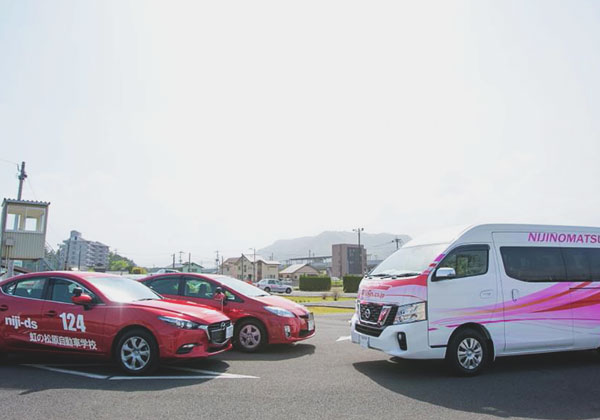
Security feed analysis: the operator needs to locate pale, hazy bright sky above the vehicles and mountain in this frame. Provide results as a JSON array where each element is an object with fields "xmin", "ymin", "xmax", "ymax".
[{"xmin": 0, "ymin": 0, "xmax": 600, "ymax": 266}]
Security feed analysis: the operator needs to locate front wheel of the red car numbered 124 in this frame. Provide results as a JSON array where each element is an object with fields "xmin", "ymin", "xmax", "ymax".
[{"xmin": 115, "ymin": 328, "xmax": 159, "ymax": 376}]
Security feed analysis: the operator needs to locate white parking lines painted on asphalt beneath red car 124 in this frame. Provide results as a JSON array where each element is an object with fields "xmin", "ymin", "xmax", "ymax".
[{"xmin": 22, "ymin": 364, "xmax": 260, "ymax": 381}]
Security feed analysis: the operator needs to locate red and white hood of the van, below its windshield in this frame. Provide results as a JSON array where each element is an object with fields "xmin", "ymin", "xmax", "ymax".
[{"xmin": 358, "ymin": 274, "xmax": 427, "ymax": 305}]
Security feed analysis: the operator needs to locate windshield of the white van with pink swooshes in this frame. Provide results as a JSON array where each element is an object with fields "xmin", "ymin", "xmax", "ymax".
[{"xmin": 369, "ymin": 244, "xmax": 449, "ymax": 277}]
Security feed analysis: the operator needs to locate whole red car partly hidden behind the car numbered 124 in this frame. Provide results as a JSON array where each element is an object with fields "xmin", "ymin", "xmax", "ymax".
[{"xmin": 140, "ymin": 273, "xmax": 315, "ymax": 352}]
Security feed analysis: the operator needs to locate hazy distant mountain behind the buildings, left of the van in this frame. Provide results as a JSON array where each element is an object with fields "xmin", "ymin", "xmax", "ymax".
[{"xmin": 258, "ymin": 231, "xmax": 410, "ymax": 262}]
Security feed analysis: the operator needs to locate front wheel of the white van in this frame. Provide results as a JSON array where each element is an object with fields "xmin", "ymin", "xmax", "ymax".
[{"xmin": 446, "ymin": 328, "xmax": 490, "ymax": 376}]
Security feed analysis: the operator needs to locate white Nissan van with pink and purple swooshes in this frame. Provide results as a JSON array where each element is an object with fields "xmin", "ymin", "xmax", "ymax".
[{"xmin": 352, "ymin": 224, "xmax": 600, "ymax": 375}]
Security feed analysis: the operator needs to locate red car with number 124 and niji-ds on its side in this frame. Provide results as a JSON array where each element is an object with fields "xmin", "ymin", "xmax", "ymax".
[{"xmin": 0, "ymin": 272, "xmax": 233, "ymax": 375}]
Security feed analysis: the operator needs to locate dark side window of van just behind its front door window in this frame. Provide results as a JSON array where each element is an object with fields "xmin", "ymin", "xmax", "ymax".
[{"xmin": 500, "ymin": 246, "xmax": 567, "ymax": 282}]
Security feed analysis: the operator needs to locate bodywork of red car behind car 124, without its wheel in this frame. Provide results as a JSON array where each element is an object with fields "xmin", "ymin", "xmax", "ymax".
[{"xmin": 139, "ymin": 273, "xmax": 315, "ymax": 344}]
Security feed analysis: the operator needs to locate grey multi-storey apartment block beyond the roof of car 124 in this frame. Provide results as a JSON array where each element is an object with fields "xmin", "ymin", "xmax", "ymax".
[{"xmin": 58, "ymin": 230, "xmax": 109, "ymax": 270}]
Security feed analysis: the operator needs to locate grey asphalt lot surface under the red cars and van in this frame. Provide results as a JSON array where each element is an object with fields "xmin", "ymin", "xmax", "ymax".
[{"xmin": 0, "ymin": 314, "xmax": 600, "ymax": 419}]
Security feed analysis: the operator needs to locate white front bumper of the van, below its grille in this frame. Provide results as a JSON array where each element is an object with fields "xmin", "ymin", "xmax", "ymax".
[{"xmin": 351, "ymin": 315, "xmax": 446, "ymax": 359}]
